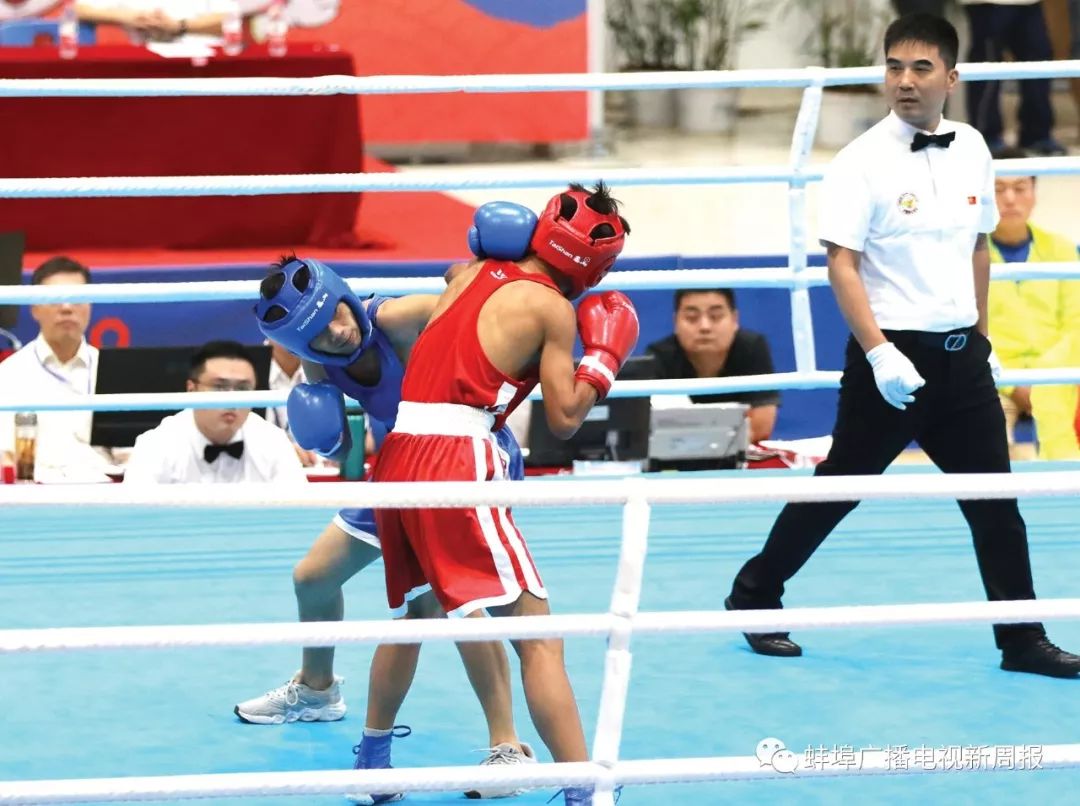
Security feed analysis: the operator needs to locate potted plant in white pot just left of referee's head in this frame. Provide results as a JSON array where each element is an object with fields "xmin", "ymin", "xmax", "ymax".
[{"xmin": 788, "ymin": 0, "xmax": 889, "ymax": 148}]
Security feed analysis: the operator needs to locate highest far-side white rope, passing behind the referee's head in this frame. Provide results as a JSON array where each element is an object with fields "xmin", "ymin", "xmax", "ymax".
[{"xmin": 0, "ymin": 59, "xmax": 1080, "ymax": 97}]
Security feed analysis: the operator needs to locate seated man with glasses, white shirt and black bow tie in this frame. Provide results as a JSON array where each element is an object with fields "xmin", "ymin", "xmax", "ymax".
[{"xmin": 124, "ymin": 341, "xmax": 307, "ymax": 484}]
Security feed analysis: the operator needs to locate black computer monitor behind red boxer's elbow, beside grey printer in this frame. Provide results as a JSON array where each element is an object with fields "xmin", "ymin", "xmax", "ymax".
[{"xmin": 525, "ymin": 355, "xmax": 656, "ymax": 468}]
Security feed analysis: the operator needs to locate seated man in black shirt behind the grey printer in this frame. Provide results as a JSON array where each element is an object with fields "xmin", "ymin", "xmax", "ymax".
[{"xmin": 647, "ymin": 288, "xmax": 780, "ymax": 442}]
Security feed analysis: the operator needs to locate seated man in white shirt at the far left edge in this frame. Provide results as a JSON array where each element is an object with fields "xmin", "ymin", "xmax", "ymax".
[{"xmin": 0, "ymin": 257, "xmax": 112, "ymax": 481}]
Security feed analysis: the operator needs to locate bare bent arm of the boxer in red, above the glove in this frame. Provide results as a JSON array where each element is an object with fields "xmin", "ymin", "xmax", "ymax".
[{"xmin": 540, "ymin": 297, "xmax": 596, "ymax": 440}]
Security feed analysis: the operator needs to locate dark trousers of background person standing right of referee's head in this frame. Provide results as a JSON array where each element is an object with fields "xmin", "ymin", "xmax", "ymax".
[{"xmin": 963, "ymin": 3, "xmax": 1054, "ymax": 146}]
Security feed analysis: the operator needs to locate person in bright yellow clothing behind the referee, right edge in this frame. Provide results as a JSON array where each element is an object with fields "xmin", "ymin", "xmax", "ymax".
[{"xmin": 988, "ymin": 146, "xmax": 1080, "ymax": 459}]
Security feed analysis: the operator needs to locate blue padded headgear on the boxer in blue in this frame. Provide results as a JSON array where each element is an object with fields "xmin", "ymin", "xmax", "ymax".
[{"xmin": 255, "ymin": 258, "xmax": 372, "ymax": 366}]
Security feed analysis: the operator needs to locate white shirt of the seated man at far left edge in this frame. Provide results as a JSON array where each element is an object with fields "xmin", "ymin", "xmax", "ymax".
[{"xmin": 0, "ymin": 334, "xmax": 111, "ymax": 481}]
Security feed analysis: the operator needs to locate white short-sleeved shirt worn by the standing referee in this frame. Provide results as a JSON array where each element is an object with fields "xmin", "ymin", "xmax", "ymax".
[{"xmin": 819, "ymin": 113, "xmax": 998, "ymax": 333}]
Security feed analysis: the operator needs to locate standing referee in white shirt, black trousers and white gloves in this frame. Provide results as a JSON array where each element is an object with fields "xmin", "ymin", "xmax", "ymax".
[{"xmin": 725, "ymin": 14, "xmax": 1080, "ymax": 677}]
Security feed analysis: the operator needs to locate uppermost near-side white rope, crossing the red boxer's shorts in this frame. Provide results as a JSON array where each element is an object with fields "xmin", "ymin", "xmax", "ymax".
[{"xmin": 0, "ymin": 470, "xmax": 1080, "ymax": 510}]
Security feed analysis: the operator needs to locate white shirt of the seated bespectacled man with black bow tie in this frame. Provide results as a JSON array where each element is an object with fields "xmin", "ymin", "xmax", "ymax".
[{"xmin": 124, "ymin": 408, "xmax": 308, "ymax": 484}]
